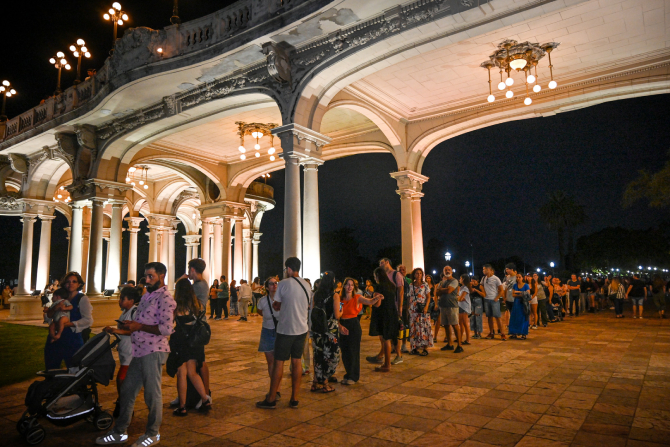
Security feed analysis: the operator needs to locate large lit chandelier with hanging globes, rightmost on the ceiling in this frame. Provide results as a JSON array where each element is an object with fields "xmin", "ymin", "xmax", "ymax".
[{"xmin": 480, "ymin": 39, "xmax": 560, "ymax": 106}]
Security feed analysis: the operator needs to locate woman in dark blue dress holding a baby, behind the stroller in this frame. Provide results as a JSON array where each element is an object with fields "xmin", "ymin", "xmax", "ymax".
[{"xmin": 44, "ymin": 272, "xmax": 93, "ymax": 369}]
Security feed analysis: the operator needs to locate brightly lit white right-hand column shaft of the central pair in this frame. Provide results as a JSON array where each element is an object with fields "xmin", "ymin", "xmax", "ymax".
[{"xmin": 302, "ymin": 161, "xmax": 321, "ymax": 281}]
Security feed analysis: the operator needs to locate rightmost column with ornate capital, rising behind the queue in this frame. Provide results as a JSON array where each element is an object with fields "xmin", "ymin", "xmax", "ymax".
[{"xmin": 391, "ymin": 170, "xmax": 428, "ymax": 271}]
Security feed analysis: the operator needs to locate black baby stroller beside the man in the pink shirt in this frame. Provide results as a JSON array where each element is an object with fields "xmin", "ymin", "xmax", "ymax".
[{"xmin": 16, "ymin": 332, "xmax": 119, "ymax": 445}]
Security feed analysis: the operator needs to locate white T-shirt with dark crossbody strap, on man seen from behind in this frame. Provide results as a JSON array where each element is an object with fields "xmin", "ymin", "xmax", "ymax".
[{"xmin": 275, "ymin": 277, "xmax": 312, "ymax": 335}]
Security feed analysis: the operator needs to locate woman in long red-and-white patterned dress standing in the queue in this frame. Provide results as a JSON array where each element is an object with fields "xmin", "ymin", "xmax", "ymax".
[{"xmin": 408, "ymin": 268, "xmax": 433, "ymax": 356}]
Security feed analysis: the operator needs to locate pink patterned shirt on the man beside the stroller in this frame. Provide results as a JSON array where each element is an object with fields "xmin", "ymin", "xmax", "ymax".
[{"xmin": 130, "ymin": 286, "xmax": 177, "ymax": 357}]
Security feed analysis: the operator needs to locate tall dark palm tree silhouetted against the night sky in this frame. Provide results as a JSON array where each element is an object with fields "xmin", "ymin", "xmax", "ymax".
[{"xmin": 540, "ymin": 191, "xmax": 586, "ymax": 269}]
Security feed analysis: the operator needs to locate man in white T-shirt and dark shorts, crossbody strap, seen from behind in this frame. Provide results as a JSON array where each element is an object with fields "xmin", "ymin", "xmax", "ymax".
[{"xmin": 256, "ymin": 257, "xmax": 312, "ymax": 409}]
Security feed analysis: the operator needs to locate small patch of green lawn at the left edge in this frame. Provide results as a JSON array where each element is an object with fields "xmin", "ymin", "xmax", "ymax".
[{"xmin": 0, "ymin": 323, "xmax": 49, "ymax": 386}]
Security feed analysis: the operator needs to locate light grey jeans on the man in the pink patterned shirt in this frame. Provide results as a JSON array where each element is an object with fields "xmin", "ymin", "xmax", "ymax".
[{"xmin": 114, "ymin": 352, "xmax": 168, "ymax": 436}]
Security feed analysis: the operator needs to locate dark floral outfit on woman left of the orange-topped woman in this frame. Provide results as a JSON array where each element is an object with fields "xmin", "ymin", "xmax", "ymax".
[{"xmin": 310, "ymin": 295, "xmax": 340, "ymax": 384}]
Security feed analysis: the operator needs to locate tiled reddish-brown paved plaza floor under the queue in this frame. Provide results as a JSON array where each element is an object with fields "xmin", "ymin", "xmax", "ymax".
[{"xmin": 0, "ymin": 311, "xmax": 670, "ymax": 447}]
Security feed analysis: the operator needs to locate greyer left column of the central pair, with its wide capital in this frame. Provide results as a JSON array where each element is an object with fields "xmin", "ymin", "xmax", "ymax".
[{"xmin": 272, "ymin": 123, "xmax": 331, "ymax": 265}]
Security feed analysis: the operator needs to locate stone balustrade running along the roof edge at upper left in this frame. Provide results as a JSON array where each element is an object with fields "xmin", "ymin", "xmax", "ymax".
[{"xmin": 0, "ymin": 0, "xmax": 312, "ymax": 142}]
